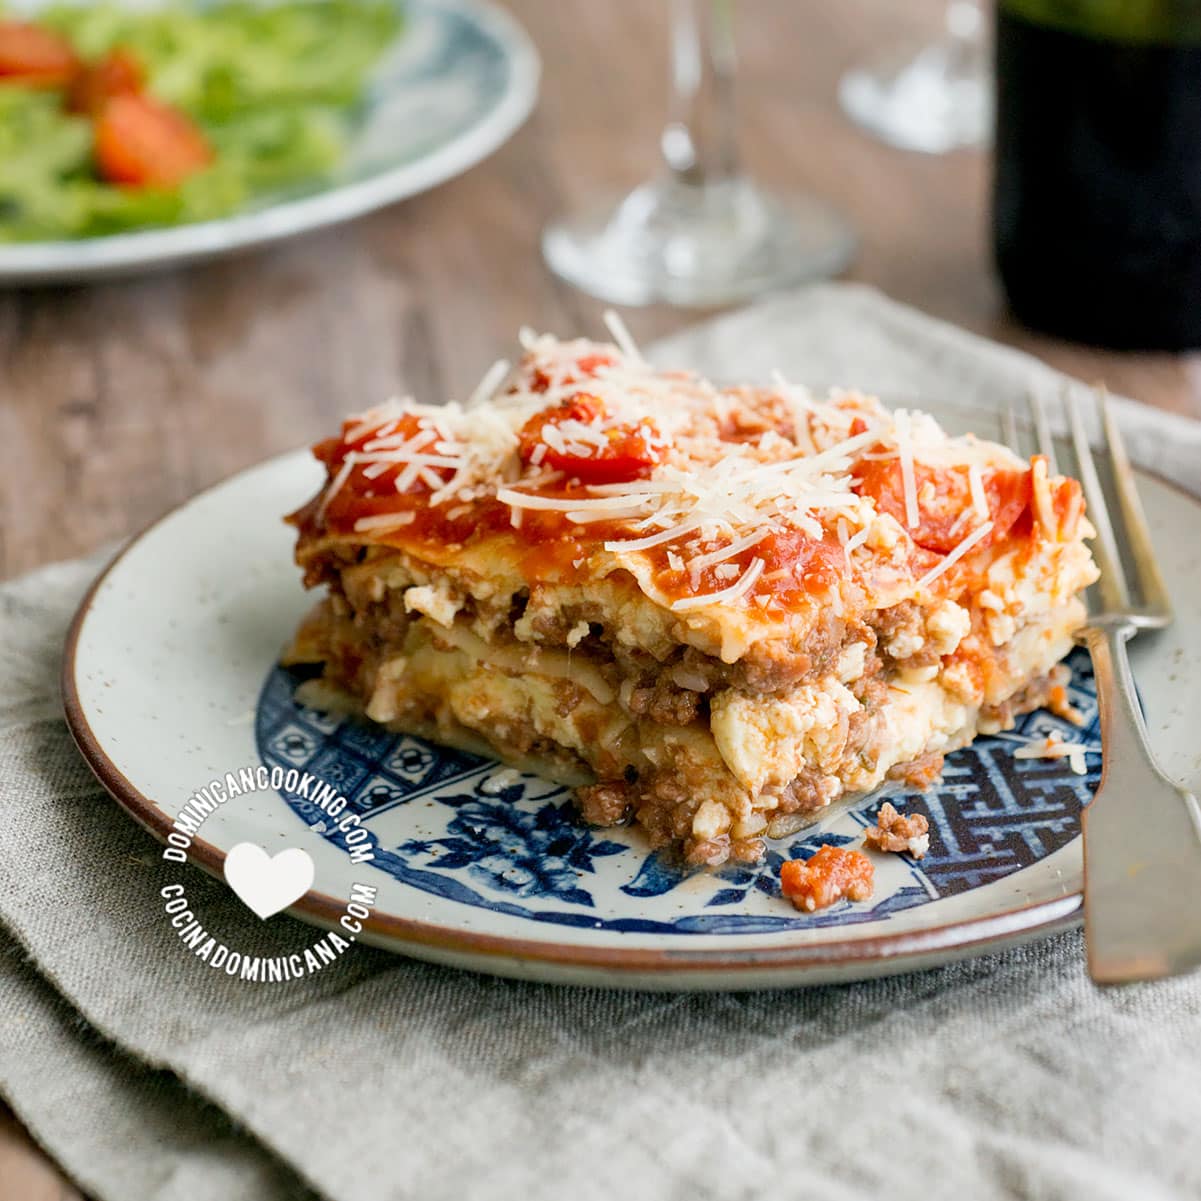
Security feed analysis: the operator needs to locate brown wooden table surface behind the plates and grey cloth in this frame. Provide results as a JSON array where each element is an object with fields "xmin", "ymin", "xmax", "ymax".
[{"xmin": 0, "ymin": 0, "xmax": 1201, "ymax": 1201}]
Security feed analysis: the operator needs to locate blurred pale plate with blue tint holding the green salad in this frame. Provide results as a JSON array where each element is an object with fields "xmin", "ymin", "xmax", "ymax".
[{"xmin": 0, "ymin": 0, "xmax": 539, "ymax": 283}]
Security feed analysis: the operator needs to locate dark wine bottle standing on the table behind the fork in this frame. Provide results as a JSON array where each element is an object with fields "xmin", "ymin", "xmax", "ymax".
[{"xmin": 993, "ymin": 0, "xmax": 1201, "ymax": 349}]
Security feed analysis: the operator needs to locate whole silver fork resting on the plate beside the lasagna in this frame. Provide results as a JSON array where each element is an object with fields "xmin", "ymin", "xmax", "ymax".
[{"xmin": 1005, "ymin": 389, "xmax": 1201, "ymax": 984}]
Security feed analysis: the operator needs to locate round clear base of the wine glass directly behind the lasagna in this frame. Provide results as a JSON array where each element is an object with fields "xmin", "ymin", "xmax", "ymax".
[{"xmin": 542, "ymin": 178, "xmax": 856, "ymax": 309}]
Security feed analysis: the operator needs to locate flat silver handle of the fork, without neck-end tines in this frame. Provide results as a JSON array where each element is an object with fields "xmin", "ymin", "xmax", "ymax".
[{"xmin": 1082, "ymin": 622, "xmax": 1201, "ymax": 984}]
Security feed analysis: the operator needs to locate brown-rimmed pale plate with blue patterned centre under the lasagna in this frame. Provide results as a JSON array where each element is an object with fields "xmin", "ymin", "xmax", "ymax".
[{"xmin": 64, "ymin": 408, "xmax": 1201, "ymax": 988}]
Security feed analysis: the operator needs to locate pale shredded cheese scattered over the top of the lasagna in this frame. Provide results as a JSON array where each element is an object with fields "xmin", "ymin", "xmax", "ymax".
[{"xmin": 316, "ymin": 329, "xmax": 1071, "ymax": 611}]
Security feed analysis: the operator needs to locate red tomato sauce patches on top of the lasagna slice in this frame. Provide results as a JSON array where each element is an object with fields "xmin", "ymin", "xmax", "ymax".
[{"xmin": 293, "ymin": 365, "xmax": 1056, "ymax": 610}]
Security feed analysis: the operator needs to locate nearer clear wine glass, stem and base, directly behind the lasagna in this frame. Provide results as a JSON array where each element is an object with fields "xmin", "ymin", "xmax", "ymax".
[{"xmin": 542, "ymin": 0, "xmax": 855, "ymax": 307}]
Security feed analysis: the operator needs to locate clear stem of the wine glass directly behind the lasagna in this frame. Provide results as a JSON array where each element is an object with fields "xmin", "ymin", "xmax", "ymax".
[{"xmin": 661, "ymin": 0, "xmax": 739, "ymax": 187}]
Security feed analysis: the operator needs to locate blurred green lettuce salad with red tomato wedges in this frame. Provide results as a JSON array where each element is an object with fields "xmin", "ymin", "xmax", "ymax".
[{"xmin": 0, "ymin": 0, "xmax": 400, "ymax": 241}]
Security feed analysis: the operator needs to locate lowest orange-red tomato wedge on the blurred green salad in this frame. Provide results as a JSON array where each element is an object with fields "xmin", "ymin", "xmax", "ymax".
[{"xmin": 96, "ymin": 95, "xmax": 213, "ymax": 187}]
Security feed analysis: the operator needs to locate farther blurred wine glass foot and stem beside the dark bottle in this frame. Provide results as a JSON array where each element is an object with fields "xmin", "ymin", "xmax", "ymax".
[{"xmin": 838, "ymin": 0, "xmax": 992, "ymax": 154}]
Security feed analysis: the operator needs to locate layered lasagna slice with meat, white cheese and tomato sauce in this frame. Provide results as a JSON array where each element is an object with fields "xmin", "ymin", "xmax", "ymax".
[{"xmin": 286, "ymin": 329, "xmax": 1097, "ymax": 865}]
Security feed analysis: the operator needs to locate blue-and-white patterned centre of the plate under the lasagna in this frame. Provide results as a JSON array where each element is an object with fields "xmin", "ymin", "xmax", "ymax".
[{"xmin": 256, "ymin": 651, "xmax": 1100, "ymax": 934}]
